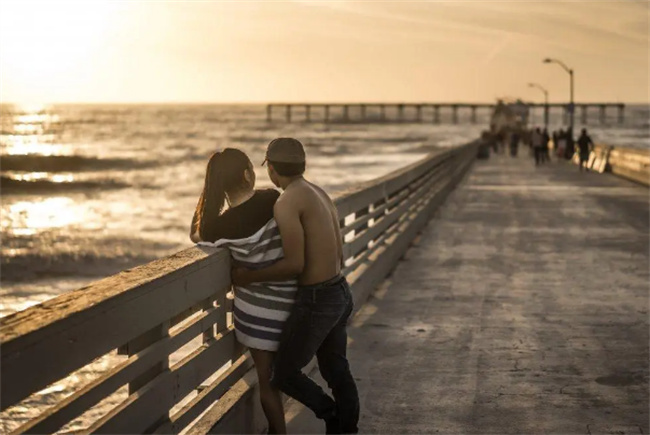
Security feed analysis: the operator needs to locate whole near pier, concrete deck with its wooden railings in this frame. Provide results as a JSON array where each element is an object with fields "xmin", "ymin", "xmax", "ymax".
[{"xmin": 0, "ymin": 141, "xmax": 650, "ymax": 434}]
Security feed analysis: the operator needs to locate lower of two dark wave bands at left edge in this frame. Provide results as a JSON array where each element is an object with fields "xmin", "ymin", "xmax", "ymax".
[{"xmin": 0, "ymin": 175, "xmax": 131, "ymax": 195}]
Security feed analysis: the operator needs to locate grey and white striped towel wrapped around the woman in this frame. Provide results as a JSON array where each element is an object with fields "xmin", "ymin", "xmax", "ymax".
[{"xmin": 199, "ymin": 219, "xmax": 297, "ymax": 351}]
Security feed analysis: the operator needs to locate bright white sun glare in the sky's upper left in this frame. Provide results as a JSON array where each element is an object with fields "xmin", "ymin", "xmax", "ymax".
[{"xmin": 0, "ymin": 0, "xmax": 119, "ymax": 103}]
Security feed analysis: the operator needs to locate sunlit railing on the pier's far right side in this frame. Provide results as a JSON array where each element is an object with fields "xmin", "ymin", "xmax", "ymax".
[{"xmin": 573, "ymin": 145, "xmax": 650, "ymax": 186}]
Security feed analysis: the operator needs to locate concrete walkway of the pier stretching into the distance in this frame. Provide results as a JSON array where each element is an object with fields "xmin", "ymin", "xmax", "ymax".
[{"xmin": 287, "ymin": 152, "xmax": 650, "ymax": 434}]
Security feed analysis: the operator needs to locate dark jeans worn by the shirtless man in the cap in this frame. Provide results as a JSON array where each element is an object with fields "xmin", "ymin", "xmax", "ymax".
[{"xmin": 271, "ymin": 276, "xmax": 359, "ymax": 433}]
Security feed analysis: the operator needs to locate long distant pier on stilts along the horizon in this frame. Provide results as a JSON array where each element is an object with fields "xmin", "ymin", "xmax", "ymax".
[{"xmin": 266, "ymin": 103, "xmax": 625, "ymax": 124}]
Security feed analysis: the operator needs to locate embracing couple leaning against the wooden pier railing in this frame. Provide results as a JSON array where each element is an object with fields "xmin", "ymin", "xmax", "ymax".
[{"xmin": 190, "ymin": 138, "xmax": 359, "ymax": 433}]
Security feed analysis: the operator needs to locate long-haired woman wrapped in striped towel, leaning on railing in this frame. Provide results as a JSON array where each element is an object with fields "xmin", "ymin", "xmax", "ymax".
[{"xmin": 190, "ymin": 148, "xmax": 296, "ymax": 433}]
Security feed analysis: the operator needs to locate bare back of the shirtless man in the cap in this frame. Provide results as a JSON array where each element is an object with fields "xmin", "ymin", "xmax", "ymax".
[{"xmin": 278, "ymin": 179, "xmax": 342, "ymax": 285}]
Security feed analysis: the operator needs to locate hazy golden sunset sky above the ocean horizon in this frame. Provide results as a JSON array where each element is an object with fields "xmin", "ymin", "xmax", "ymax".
[{"xmin": 0, "ymin": 0, "xmax": 650, "ymax": 103}]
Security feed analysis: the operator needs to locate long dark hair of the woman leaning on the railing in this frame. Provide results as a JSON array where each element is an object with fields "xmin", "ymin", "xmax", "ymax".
[{"xmin": 194, "ymin": 148, "xmax": 252, "ymax": 240}]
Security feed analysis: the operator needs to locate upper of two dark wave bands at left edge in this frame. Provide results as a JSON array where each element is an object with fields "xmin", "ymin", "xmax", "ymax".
[{"xmin": 2, "ymin": 154, "xmax": 154, "ymax": 172}]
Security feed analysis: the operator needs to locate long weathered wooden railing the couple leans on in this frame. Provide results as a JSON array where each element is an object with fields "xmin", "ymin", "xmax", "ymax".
[{"xmin": 0, "ymin": 143, "xmax": 477, "ymax": 433}]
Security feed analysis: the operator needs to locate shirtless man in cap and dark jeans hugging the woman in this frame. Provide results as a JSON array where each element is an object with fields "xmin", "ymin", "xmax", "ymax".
[{"xmin": 232, "ymin": 138, "xmax": 359, "ymax": 433}]
